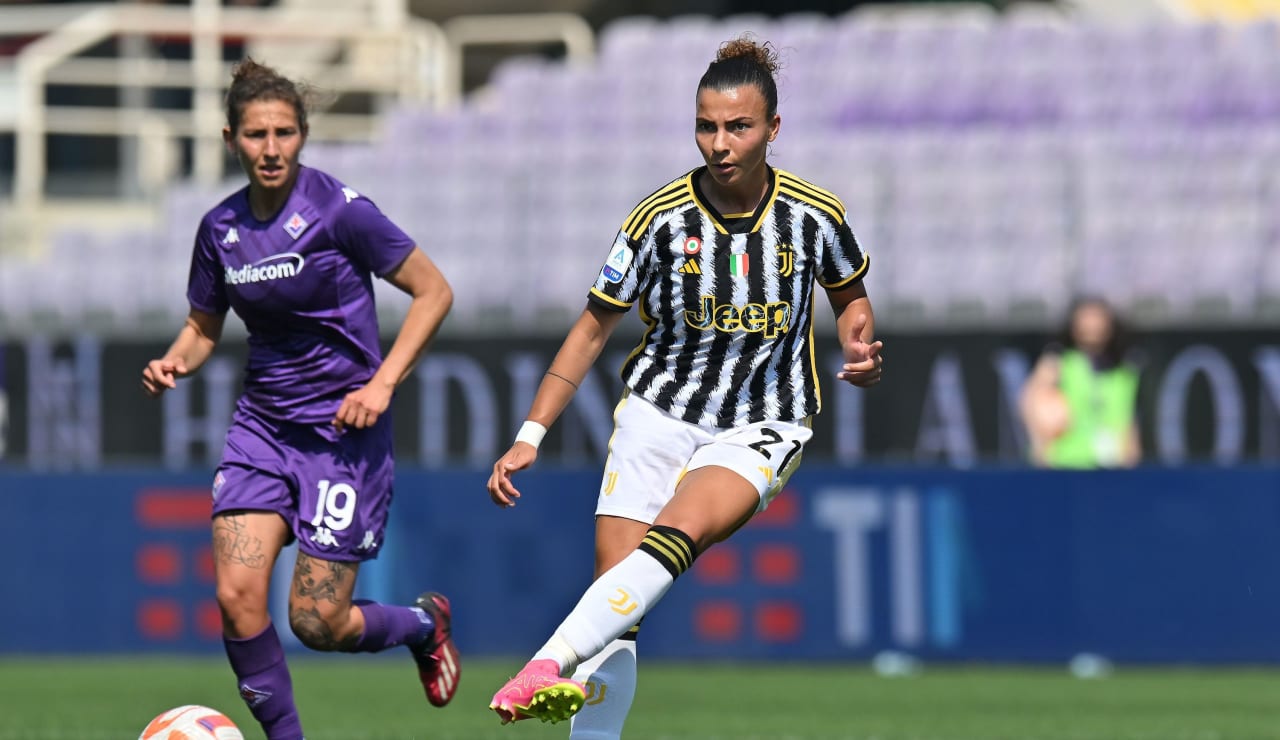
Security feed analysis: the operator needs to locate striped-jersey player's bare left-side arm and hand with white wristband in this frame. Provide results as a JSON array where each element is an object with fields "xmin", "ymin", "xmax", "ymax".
[{"xmin": 488, "ymin": 301, "xmax": 623, "ymax": 507}]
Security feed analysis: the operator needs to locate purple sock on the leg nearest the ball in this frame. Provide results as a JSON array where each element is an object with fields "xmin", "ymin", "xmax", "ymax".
[{"xmin": 223, "ymin": 625, "xmax": 302, "ymax": 740}]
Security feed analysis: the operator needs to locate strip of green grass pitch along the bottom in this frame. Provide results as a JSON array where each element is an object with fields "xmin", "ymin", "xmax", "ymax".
[{"xmin": 0, "ymin": 656, "xmax": 1280, "ymax": 740}]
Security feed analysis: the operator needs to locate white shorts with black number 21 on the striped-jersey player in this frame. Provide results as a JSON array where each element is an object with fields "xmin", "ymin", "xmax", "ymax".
[{"xmin": 595, "ymin": 393, "xmax": 813, "ymax": 524}]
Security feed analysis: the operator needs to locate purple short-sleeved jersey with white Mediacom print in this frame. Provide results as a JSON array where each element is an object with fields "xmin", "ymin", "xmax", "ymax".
[{"xmin": 187, "ymin": 166, "xmax": 415, "ymax": 424}]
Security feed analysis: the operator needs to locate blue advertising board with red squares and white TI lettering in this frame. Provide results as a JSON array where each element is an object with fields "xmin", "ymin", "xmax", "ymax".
[{"xmin": 0, "ymin": 466, "xmax": 1280, "ymax": 662}]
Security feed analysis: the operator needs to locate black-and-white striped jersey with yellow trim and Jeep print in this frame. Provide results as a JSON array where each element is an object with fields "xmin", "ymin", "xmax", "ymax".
[{"xmin": 590, "ymin": 161, "xmax": 869, "ymax": 429}]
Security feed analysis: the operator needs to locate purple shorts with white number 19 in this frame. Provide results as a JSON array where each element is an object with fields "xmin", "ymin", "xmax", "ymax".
[{"xmin": 214, "ymin": 408, "xmax": 396, "ymax": 561}]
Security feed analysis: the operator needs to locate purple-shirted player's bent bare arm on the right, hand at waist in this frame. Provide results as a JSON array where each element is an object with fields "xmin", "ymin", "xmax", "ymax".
[{"xmin": 333, "ymin": 248, "xmax": 453, "ymax": 429}]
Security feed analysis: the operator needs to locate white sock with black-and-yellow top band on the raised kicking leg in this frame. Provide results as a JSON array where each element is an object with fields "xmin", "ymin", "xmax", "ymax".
[{"xmin": 534, "ymin": 526, "xmax": 694, "ymax": 676}]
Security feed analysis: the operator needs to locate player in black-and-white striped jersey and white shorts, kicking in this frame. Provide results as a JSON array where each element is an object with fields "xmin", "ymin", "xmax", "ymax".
[{"xmin": 488, "ymin": 37, "xmax": 882, "ymax": 737}]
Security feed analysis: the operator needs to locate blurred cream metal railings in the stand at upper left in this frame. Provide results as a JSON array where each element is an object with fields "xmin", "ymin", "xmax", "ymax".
[{"xmin": 0, "ymin": 0, "xmax": 593, "ymax": 207}]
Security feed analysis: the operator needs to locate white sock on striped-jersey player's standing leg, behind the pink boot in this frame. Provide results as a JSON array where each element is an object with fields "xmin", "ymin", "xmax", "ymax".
[{"xmin": 568, "ymin": 635, "xmax": 636, "ymax": 740}]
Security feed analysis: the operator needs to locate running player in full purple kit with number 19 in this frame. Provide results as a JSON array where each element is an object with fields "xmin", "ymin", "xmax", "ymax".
[{"xmin": 142, "ymin": 60, "xmax": 460, "ymax": 740}]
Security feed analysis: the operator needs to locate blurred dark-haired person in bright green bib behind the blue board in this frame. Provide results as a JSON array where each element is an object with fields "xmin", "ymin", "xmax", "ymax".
[{"xmin": 1020, "ymin": 298, "xmax": 1142, "ymax": 469}]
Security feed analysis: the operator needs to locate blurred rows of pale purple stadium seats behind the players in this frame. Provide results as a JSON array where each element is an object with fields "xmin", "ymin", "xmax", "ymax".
[{"xmin": 30, "ymin": 9, "xmax": 1280, "ymax": 323}]
